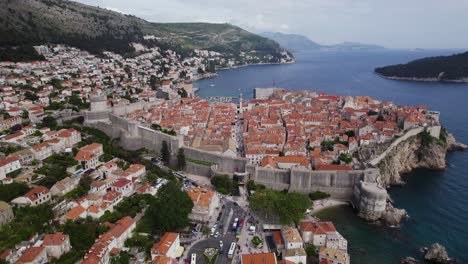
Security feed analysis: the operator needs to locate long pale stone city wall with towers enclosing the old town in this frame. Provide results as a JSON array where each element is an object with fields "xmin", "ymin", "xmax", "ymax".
[{"xmin": 85, "ymin": 96, "xmax": 440, "ymax": 221}]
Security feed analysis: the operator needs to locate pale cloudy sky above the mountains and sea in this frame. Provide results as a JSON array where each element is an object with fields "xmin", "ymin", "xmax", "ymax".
[{"xmin": 77, "ymin": 0, "xmax": 468, "ymax": 48}]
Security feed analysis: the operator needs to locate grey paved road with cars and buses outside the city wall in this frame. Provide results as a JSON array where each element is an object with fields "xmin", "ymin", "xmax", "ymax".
[{"xmin": 187, "ymin": 199, "xmax": 246, "ymax": 264}]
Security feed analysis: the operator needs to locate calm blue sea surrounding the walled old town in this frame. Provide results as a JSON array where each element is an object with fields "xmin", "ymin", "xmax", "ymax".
[{"xmin": 195, "ymin": 50, "xmax": 468, "ymax": 264}]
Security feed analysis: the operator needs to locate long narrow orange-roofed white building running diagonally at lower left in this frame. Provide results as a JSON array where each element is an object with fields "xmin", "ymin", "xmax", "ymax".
[{"xmin": 81, "ymin": 216, "xmax": 136, "ymax": 264}]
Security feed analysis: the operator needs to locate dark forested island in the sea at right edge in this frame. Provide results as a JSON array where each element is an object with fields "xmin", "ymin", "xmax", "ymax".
[{"xmin": 374, "ymin": 52, "xmax": 468, "ymax": 82}]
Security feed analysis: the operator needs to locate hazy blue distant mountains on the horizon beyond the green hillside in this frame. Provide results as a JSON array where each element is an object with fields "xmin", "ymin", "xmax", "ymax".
[{"xmin": 260, "ymin": 32, "xmax": 385, "ymax": 52}]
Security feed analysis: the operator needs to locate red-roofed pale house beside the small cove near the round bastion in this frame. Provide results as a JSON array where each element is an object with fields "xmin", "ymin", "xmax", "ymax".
[{"xmin": 299, "ymin": 221, "xmax": 336, "ymax": 247}]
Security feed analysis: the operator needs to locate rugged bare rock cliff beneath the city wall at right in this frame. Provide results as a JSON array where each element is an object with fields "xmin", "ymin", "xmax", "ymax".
[{"xmin": 378, "ymin": 134, "xmax": 467, "ymax": 186}]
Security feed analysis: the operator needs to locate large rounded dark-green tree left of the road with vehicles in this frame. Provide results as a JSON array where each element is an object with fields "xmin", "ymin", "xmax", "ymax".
[{"xmin": 145, "ymin": 181, "xmax": 193, "ymax": 233}]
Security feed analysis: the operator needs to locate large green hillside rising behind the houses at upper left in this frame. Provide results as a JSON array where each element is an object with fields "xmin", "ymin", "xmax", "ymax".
[{"xmin": 0, "ymin": 0, "xmax": 290, "ymax": 60}]
